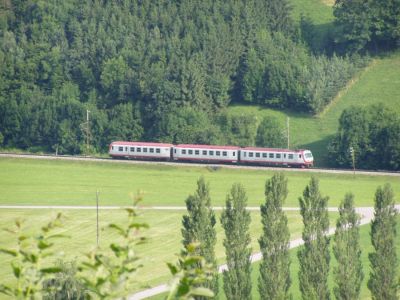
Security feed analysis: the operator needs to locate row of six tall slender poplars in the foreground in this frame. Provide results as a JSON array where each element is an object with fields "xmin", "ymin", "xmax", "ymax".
[{"xmin": 182, "ymin": 173, "xmax": 398, "ymax": 300}]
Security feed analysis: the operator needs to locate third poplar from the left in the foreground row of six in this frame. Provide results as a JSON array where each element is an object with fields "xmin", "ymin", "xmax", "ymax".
[{"xmin": 258, "ymin": 173, "xmax": 291, "ymax": 299}]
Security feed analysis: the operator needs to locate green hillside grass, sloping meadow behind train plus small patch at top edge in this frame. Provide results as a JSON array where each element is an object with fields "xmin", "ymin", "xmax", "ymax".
[{"xmin": 229, "ymin": 0, "xmax": 400, "ymax": 166}]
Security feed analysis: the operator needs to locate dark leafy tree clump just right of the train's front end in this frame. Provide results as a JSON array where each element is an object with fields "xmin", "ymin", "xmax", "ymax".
[{"xmin": 329, "ymin": 104, "xmax": 400, "ymax": 170}]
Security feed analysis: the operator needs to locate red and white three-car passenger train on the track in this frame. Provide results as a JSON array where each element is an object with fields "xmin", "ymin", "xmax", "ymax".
[{"xmin": 109, "ymin": 141, "xmax": 314, "ymax": 167}]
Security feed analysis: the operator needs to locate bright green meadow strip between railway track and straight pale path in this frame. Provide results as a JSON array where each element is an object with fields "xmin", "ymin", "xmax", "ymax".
[{"xmin": 0, "ymin": 158, "xmax": 400, "ymax": 207}]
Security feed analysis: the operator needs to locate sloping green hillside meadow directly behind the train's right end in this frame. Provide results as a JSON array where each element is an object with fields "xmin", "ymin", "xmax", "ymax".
[{"xmin": 229, "ymin": 52, "xmax": 400, "ymax": 167}]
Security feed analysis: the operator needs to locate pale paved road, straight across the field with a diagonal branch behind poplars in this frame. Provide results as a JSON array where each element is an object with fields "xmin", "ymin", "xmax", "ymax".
[{"xmin": 0, "ymin": 205, "xmax": 400, "ymax": 300}]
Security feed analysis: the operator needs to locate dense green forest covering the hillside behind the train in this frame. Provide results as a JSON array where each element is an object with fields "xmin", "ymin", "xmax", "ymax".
[{"xmin": 0, "ymin": 0, "xmax": 400, "ymax": 166}]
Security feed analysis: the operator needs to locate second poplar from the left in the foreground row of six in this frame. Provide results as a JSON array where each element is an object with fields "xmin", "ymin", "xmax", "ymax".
[{"xmin": 221, "ymin": 184, "xmax": 251, "ymax": 300}]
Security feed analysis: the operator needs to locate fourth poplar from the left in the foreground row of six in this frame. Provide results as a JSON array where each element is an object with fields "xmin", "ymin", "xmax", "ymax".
[{"xmin": 297, "ymin": 177, "xmax": 330, "ymax": 300}]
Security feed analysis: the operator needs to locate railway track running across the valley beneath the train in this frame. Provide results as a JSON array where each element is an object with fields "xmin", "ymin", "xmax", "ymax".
[{"xmin": 0, "ymin": 152, "xmax": 400, "ymax": 177}]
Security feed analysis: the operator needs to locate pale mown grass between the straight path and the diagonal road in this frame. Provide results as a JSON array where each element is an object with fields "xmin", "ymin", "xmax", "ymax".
[{"xmin": 0, "ymin": 209, "xmax": 337, "ymax": 298}]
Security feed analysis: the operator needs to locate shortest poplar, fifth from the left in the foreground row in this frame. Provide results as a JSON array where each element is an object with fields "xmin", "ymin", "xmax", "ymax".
[{"xmin": 333, "ymin": 193, "xmax": 364, "ymax": 300}]
